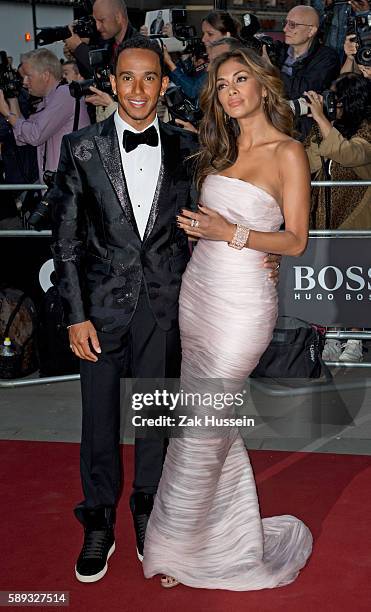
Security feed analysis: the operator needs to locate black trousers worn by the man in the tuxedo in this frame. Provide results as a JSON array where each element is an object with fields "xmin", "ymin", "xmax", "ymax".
[{"xmin": 79, "ymin": 290, "xmax": 181, "ymax": 509}]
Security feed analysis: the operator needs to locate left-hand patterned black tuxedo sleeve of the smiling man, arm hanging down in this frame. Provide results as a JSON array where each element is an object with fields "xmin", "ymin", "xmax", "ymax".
[{"xmin": 48, "ymin": 136, "xmax": 88, "ymax": 325}]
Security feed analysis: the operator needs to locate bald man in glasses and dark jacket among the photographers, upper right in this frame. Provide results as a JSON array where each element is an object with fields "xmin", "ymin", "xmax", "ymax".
[{"xmin": 281, "ymin": 5, "xmax": 340, "ymax": 140}]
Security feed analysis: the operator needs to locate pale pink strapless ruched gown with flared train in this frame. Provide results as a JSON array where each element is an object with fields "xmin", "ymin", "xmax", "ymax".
[{"xmin": 143, "ymin": 175, "xmax": 312, "ymax": 591}]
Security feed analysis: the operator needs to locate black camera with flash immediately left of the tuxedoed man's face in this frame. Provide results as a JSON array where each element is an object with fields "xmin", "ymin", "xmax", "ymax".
[{"xmin": 69, "ymin": 49, "xmax": 113, "ymax": 99}]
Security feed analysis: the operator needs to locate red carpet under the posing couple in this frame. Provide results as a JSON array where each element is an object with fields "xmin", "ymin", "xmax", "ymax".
[{"xmin": 0, "ymin": 441, "xmax": 371, "ymax": 612}]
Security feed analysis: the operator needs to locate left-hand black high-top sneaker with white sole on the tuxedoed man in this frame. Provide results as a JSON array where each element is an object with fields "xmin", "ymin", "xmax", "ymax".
[{"xmin": 75, "ymin": 508, "xmax": 115, "ymax": 582}]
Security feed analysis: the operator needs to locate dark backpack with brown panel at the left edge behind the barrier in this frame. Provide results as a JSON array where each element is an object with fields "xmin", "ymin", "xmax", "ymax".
[{"xmin": 0, "ymin": 287, "xmax": 38, "ymax": 379}]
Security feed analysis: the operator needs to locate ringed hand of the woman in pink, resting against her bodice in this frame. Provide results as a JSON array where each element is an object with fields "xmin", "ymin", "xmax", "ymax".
[{"xmin": 177, "ymin": 204, "xmax": 236, "ymax": 242}]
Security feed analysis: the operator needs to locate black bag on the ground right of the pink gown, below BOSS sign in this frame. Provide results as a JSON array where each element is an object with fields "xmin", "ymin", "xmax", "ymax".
[{"xmin": 251, "ymin": 317, "xmax": 332, "ymax": 380}]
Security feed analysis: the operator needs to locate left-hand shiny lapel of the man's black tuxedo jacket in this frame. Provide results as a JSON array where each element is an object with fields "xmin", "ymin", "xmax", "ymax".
[{"xmin": 94, "ymin": 115, "xmax": 139, "ymax": 236}]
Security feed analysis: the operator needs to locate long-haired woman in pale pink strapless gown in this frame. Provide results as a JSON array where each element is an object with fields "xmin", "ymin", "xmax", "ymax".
[{"xmin": 143, "ymin": 49, "xmax": 312, "ymax": 591}]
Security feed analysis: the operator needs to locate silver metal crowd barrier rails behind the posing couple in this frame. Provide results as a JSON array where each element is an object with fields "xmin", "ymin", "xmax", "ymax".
[{"xmin": 0, "ymin": 180, "xmax": 371, "ymax": 384}]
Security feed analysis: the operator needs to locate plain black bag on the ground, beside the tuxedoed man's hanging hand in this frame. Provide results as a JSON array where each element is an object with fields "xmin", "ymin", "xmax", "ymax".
[{"xmin": 38, "ymin": 274, "xmax": 80, "ymax": 376}]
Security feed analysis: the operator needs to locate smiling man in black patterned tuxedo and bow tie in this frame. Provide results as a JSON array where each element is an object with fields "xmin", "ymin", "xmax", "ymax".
[{"xmin": 50, "ymin": 37, "xmax": 195, "ymax": 582}]
